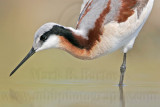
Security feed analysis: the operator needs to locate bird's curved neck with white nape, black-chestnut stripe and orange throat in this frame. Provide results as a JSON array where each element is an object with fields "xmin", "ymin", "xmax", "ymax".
[{"xmin": 56, "ymin": 23, "xmax": 103, "ymax": 59}]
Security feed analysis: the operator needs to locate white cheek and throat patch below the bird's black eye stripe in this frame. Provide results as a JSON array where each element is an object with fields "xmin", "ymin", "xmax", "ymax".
[{"xmin": 36, "ymin": 35, "xmax": 60, "ymax": 52}]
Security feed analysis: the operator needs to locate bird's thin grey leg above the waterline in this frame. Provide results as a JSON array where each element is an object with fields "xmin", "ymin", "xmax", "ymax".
[{"xmin": 119, "ymin": 53, "xmax": 127, "ymax": 86}]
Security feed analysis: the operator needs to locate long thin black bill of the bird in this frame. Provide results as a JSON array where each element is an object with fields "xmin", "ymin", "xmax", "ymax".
[{"xmin": 10, "ymin": 47, "xmax": 35, "ymax": 76}]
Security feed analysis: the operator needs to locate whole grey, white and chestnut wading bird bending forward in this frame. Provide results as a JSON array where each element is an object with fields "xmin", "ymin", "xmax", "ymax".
[{"xmin": 10, "ymin": 0, "xmax": 154, "ymax": 86}]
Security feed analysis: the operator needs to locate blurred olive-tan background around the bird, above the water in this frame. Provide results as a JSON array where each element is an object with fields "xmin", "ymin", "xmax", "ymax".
[{"xmin": 0, "ymin": 0, "xmax": 160, "ymax": 107}]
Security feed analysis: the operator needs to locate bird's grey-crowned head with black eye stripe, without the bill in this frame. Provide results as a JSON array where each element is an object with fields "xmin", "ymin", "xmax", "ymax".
[{"xmin": 33, "ymin": 23, "xmax": 60, "ymax": 52}]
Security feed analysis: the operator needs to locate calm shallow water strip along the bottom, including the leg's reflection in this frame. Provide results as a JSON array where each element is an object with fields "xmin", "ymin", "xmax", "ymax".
[{"xmin": 0, "ymin": 83, "xmax": 160, "ymax": 107}]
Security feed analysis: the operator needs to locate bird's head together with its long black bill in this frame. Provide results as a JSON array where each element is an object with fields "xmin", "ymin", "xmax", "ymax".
[{"xmin": 10, "ymin": 23, "xmax": 69, "ymax": 76}]
